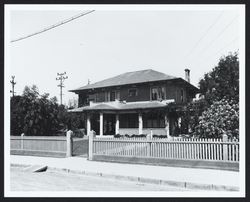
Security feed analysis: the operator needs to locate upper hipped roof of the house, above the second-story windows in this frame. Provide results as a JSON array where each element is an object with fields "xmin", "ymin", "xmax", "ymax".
[{"xmin": 70, "ymin": 69, "xmax": 176, "ymax": 92}]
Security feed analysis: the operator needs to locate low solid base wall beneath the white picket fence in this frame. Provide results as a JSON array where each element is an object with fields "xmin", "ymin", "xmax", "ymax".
[{"xmin": 92, "ymin": 154, "xmax": 239, "ymax": 171}]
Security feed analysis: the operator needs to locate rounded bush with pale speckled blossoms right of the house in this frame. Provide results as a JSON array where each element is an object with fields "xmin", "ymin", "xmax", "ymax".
[{"xmin": 195, "ymin": 99, "xmax": 239, "ymax": 138}]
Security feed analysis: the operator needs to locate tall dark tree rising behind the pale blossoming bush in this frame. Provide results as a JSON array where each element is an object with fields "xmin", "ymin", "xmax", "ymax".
[{"xmin": 199, "ymin": 52, "xmax": 239, "ymax": 105}]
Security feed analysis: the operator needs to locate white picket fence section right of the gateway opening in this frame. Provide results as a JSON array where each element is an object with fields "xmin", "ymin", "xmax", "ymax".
[{"xmin": 90, "ymin": 136, "xmax": 239, "ymax": 162}]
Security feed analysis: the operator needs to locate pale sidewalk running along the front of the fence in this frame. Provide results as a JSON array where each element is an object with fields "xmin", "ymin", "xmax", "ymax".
[{"xmin": 10, "ymin": 155, "xmax": 240, "ymax": 191}]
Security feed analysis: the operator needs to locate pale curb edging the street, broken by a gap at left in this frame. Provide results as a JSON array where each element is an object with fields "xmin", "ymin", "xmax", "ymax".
[{"xmin": 10, "ymin": 163, "xmax": 239, "ymax": 191}]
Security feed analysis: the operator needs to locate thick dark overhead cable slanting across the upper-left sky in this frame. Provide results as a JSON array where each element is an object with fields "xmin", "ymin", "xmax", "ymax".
[{"xmin": 11, "ymin": 10, "xmax": 94, "ymax": 43}]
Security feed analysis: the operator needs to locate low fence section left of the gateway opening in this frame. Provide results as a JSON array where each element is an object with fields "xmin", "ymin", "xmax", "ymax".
[{"xmin": 10, "ymin": 136, "xmax": 67, "ymax": 157}]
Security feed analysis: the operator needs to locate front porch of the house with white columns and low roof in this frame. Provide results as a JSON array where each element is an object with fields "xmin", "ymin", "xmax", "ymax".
[{"xmin": 67, "ymin": 100, "xmax": 173, "ymax": 137}]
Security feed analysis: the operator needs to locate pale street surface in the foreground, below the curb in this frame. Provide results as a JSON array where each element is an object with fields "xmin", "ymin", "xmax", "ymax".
[{"xmin": 10, "ymin": 168, "xmax": 187, "ymax": 191}]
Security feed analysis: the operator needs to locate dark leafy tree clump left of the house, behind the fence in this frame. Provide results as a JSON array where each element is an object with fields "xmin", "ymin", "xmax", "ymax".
[{"xmin": 11, "ymin": 85, "xmax": 84, "ymax": 136}]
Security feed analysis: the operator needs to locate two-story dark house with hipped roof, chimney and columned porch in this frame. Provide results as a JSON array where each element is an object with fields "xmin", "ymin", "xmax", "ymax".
[{"xmin": 69, "ymin": 69, "xmax": 198, "ymax": 136}]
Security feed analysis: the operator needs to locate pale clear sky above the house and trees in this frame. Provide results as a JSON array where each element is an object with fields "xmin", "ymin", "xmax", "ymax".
[{"xmin": 7, "ymin": 6, "xmax": 242, "ymax": 104}]
